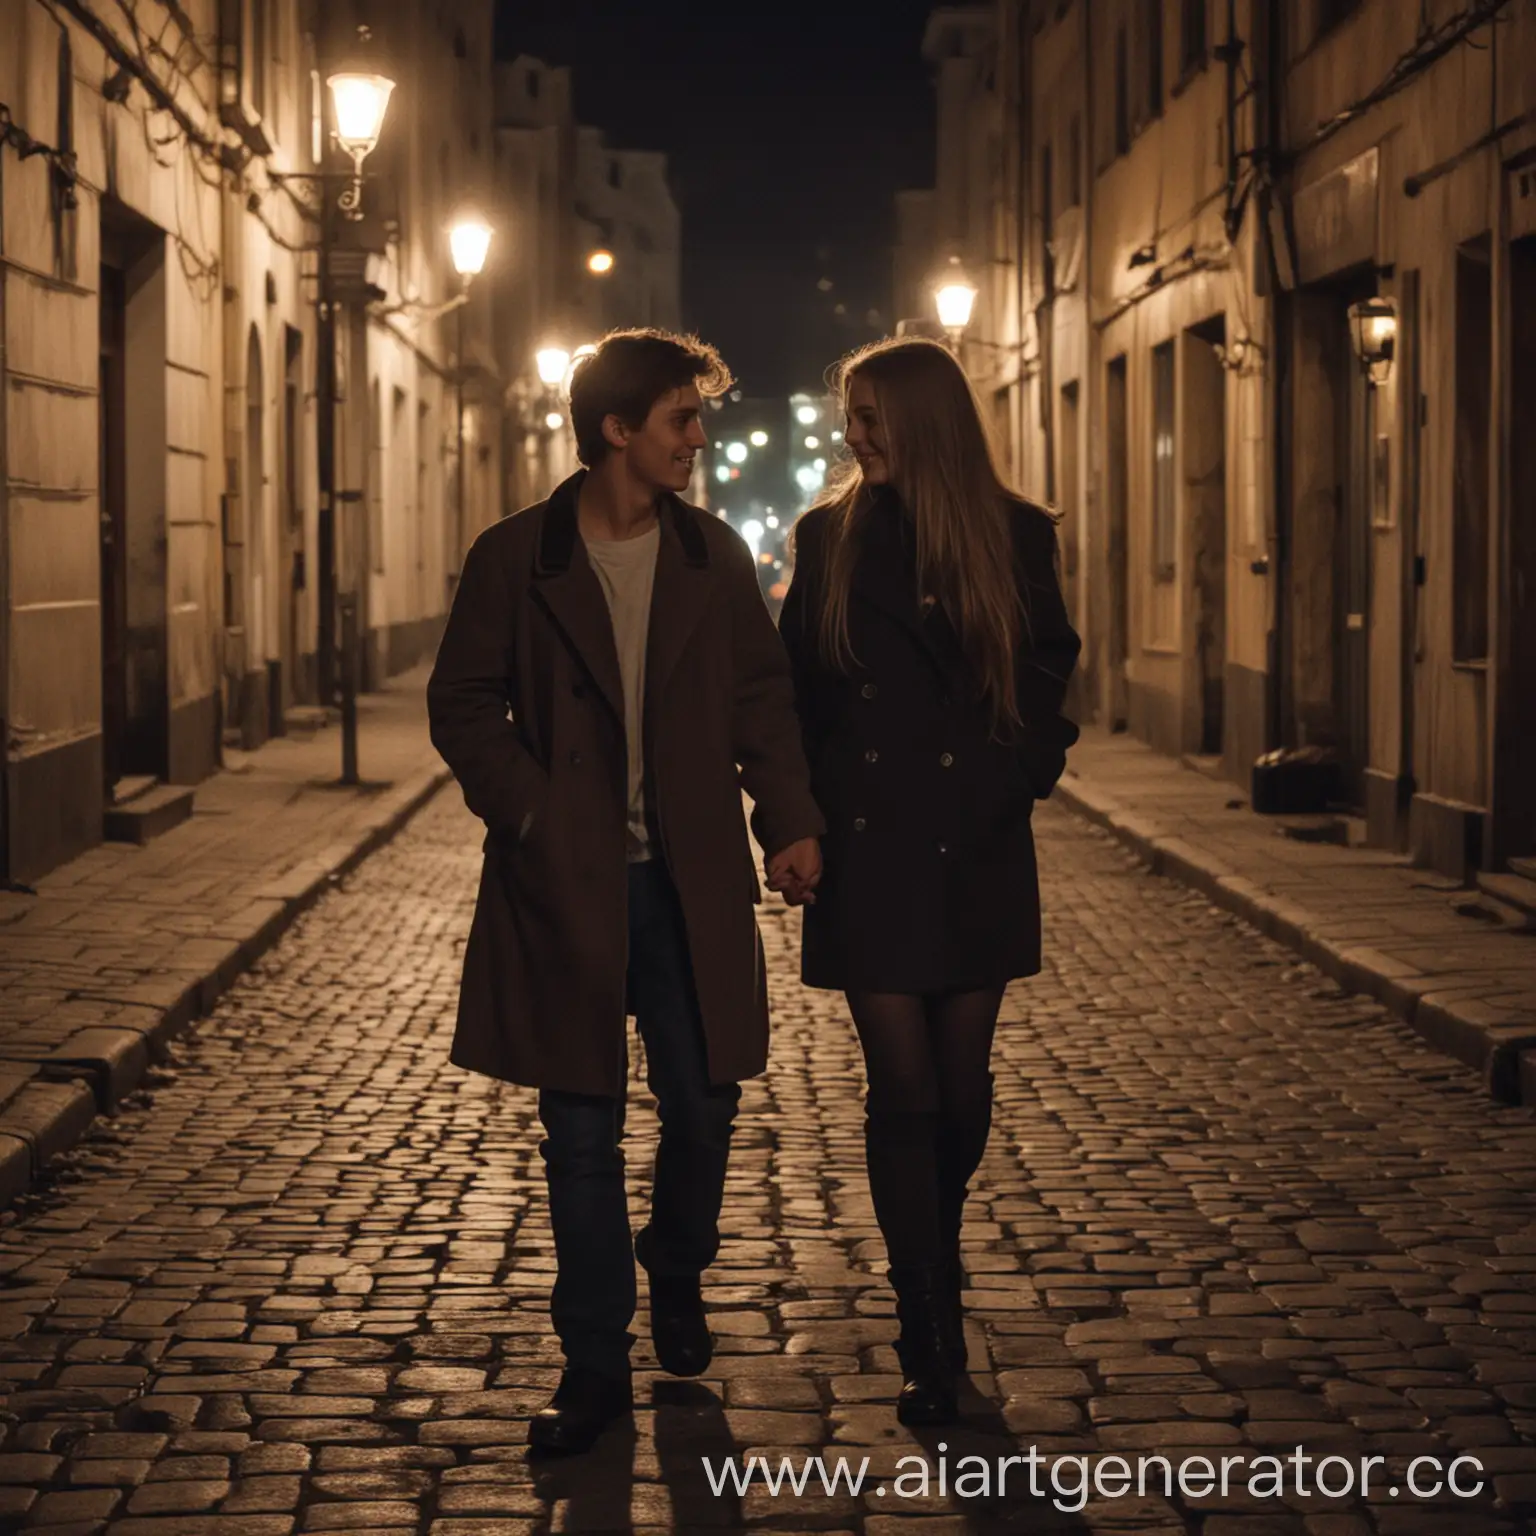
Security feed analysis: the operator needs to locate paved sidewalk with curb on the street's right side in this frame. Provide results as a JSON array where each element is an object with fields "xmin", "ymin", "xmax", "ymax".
[{"xmin": 1057, "ymin": 730, "xmax": 1536, "ymax": 1104}]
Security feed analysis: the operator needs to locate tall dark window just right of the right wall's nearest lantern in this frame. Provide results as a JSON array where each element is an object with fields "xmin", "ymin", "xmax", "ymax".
[{"xmin": 1452, "ymin": 235, "xmax": 1493, "ymax": 662}]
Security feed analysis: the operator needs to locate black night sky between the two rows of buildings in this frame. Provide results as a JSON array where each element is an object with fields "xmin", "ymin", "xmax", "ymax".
[{"xmin": 496, "ymin": 0, "xmax": 934, "ymax": 395}]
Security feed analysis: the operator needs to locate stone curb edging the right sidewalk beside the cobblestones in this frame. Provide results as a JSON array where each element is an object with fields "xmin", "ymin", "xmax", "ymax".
[{"xmin": 1055, "ymin": 773, "xmax": 1536, "ymax": 1104}]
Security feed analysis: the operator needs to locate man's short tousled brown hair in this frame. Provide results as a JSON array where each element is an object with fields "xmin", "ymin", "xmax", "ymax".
[{"xmin": 571, "ymin": 329, "xmax": 733, "ymax": 468}]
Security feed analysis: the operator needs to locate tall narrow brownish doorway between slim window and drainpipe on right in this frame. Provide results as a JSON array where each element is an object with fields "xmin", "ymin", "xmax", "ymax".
[{"xmin": 1180, "ymin": 315, "xmax": 1227, "ymax": 757}]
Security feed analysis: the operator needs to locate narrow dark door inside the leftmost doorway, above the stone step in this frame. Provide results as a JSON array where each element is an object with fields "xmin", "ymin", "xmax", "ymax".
[{"xmin": 97, "ymin": 266, "xmax": 127, "ymax": 800}]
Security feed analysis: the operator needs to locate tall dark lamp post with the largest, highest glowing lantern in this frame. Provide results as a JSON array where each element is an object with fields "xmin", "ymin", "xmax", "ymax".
[{"xmin": 312, "ymin": 71, "xmax": 395, "ymax": 785}]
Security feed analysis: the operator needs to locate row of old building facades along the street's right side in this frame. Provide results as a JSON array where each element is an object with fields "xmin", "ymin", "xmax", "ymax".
[{"xmin": 902, "ymin": 0, "xmax": 1536, "ymax": 877}]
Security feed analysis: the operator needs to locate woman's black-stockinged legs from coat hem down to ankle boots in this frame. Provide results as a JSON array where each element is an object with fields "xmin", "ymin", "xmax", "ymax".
[{"xmin": 848, "ymin": 986, "xmax": 1003, "ymax": 1272}]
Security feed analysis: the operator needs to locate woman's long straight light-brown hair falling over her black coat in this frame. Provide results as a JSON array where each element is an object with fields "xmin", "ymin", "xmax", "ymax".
[{"xmin": 814, "ymin": 336, "xmax": 1028, "ymax": 731}]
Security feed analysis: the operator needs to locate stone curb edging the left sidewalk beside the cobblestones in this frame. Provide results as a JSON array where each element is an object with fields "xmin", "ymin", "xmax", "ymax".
[{"xmin": 0, "ymin": 766, "xmax": 450, "ymax": 1209}]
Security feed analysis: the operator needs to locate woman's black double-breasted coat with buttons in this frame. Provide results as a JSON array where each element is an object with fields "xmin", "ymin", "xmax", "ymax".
[{"xmin": 779, "ymin": 492, "xmax": 1080, "ymax": 992}]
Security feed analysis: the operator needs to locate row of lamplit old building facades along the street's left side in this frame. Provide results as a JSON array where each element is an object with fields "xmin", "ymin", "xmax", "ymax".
[{"xmin": 0, "ymin": 0, "xmax": 501, "ymax": 879}]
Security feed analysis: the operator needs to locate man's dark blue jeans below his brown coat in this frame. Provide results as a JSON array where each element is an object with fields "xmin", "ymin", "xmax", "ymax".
[{"xmin": 539, "ymin": 860, "xmax": 742, "ymax": 1375}]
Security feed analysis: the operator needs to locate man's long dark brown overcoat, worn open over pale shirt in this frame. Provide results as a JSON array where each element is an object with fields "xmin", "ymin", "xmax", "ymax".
[{"xmin": 427, "ymin": 475, "xmax": 825, "ymax": 1095}]
